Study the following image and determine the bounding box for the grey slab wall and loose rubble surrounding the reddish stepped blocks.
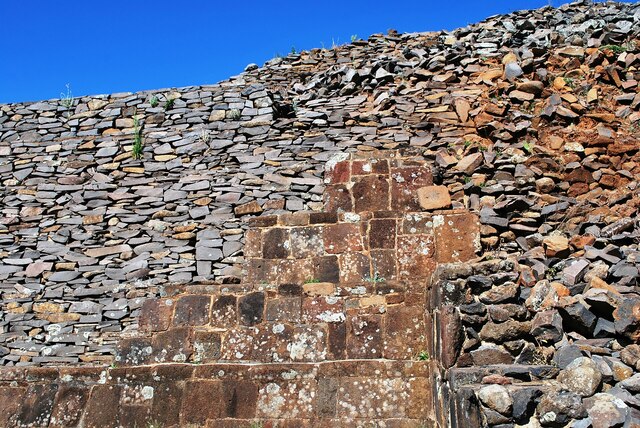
[0,3,640,426]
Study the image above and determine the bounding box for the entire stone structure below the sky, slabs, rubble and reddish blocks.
[0,2,640,427]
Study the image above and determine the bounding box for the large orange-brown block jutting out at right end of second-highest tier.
[433,213,480,263]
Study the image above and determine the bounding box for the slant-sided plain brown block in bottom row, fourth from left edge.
[83,385,121,428]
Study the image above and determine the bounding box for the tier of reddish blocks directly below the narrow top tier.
[245,210,480,284]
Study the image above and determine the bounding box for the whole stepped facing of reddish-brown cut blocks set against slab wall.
[3,152,479,427]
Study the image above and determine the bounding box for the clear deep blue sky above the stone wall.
[0,0,608,103]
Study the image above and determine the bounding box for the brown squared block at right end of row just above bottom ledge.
[383,306,427,360]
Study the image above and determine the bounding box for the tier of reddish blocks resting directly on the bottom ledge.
[116,281,430,365]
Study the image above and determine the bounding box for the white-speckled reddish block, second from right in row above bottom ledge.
[347,315,383,359]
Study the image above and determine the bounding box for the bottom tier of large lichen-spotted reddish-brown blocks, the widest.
[0,360,433,428]
